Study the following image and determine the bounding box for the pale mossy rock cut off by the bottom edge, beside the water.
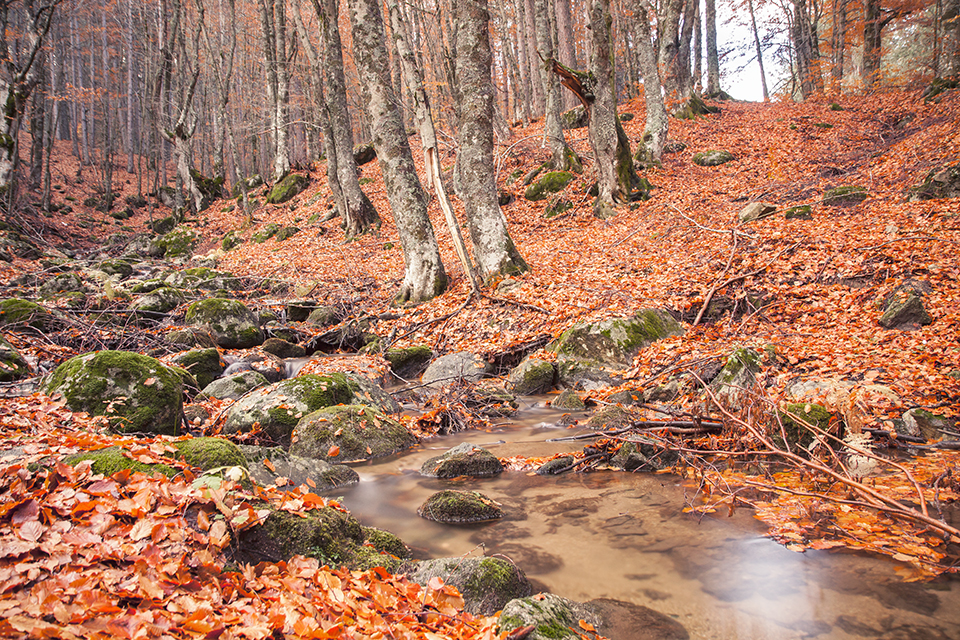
[500,593,601,640]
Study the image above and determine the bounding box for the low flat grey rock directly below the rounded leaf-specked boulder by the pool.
[240,445,360,491]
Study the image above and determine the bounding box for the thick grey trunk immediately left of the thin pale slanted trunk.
[350,0,447,304]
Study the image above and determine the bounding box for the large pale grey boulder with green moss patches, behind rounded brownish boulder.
[223,373,389,444]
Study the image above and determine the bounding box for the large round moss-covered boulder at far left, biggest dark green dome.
[43,351,183,434]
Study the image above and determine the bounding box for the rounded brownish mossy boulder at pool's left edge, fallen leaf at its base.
[290,404,417,462]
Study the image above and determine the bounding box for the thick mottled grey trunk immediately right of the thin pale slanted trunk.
[456,0,528,281]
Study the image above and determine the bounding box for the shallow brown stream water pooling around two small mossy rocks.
[342,409,960,640]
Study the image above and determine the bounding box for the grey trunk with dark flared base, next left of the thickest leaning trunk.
[313,0,378,238]
